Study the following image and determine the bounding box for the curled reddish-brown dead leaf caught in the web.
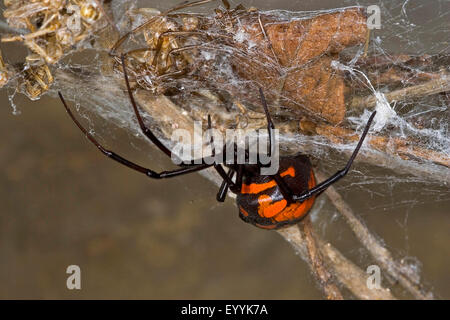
[233,8,367,123]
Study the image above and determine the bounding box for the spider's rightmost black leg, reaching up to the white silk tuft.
[293,111,377,202]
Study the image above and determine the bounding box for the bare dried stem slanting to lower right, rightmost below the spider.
[316,171,433,299]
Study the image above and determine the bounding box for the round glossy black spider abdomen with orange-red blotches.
[237,154,316,229]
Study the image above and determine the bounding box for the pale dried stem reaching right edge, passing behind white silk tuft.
[349,74,450,110]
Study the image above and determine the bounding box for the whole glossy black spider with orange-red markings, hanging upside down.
[58,56,376,229]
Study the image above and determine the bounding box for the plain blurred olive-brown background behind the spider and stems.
[0,0,450,299]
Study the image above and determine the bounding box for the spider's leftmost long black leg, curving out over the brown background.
[58,92,212,179]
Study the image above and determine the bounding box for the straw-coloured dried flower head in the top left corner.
[2,0,104,99]
